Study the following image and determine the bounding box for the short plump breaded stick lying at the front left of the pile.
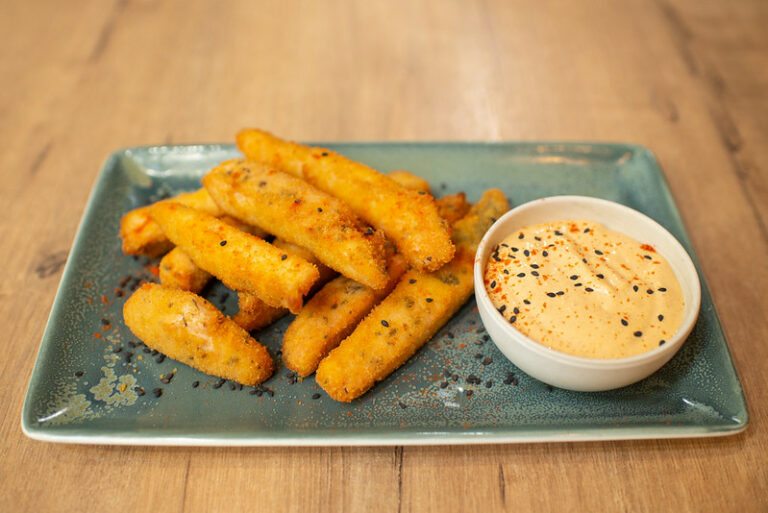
[123,283,274,386]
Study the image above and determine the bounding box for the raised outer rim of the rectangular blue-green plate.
[20,140,750,447]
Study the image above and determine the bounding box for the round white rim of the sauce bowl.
[474,195,701,370]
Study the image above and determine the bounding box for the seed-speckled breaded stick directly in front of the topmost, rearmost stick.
[203,159,387,289]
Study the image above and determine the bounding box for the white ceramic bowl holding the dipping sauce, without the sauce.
[474,196,701,392]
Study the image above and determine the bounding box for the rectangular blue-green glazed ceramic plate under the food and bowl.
[22,143,747,445]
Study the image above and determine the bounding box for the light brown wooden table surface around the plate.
[0,0,768,512]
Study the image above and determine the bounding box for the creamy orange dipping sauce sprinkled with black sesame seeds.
[484,220,685,358]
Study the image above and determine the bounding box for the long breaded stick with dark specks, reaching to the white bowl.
[315,191,509,402]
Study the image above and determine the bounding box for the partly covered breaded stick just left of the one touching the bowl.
[282,254,408,376]
